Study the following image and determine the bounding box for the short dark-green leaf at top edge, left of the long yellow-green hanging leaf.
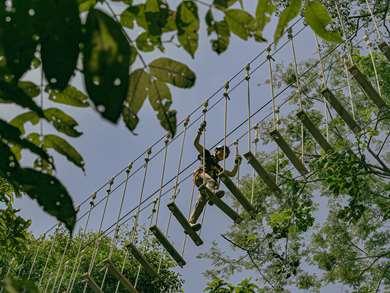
[145,0,170,36]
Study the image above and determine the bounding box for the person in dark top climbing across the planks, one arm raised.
[189,122,242,231]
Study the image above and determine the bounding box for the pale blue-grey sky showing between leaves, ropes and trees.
[1,4,354,293]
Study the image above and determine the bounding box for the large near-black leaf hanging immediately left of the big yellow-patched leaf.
[37,0,81,90]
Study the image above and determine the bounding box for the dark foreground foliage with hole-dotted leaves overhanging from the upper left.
[0,0,364,230]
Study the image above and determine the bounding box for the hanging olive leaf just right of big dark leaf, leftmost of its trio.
[123,69,150,131]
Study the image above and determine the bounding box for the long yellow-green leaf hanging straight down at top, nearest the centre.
[176,1,199,58]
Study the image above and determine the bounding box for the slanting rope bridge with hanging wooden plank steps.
[10,2,390,292]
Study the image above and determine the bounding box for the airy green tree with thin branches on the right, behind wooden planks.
[201,47,390,292]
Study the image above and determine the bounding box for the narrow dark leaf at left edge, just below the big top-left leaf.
[0,79,44,117]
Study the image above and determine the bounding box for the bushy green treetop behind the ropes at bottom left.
[0,227,182,292]
